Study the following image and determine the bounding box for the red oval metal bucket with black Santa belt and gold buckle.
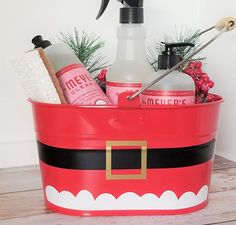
[32,92,222,215]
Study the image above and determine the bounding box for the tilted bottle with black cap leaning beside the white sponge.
[32,35,111,105]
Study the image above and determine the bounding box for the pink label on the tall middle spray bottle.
[106,81,142,105]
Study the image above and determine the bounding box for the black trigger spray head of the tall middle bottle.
[97,0,144,24]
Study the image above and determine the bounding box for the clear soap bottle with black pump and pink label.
[141,42,195,105]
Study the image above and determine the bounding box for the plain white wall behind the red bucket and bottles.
[0,0,236,168]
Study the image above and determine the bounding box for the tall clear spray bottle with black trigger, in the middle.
[97,0,154,104]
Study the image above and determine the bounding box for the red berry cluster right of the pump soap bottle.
[184,61,217,103]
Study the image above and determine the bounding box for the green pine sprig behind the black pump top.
[148,26,205,71]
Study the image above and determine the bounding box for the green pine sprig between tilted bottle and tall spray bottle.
[59,28,108,75]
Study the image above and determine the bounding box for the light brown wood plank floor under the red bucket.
[0,156,236,225]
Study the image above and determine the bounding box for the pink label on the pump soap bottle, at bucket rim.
[141,90,195,105]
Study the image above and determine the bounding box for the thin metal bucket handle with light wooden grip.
[127,17,236,100]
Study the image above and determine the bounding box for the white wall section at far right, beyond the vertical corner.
[200,0,236,161]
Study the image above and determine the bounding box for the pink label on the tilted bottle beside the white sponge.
[56,64,111,105]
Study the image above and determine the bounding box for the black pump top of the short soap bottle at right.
[158,42,195,70]
